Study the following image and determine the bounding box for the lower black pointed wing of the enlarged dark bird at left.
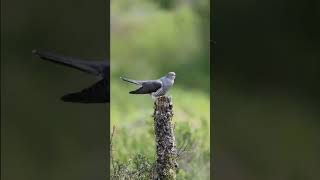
[61,79,110,103]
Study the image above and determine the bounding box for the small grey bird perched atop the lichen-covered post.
[120,72,176,98]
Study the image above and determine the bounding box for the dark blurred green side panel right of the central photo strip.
[211,0,320,180]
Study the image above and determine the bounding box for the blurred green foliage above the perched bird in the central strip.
[111,0,210,91]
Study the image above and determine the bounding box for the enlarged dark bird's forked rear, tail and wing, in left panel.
[32,49,110,104]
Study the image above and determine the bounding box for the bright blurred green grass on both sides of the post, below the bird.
[111,79,210,179]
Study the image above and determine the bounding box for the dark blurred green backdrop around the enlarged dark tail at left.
[1,0,109,180]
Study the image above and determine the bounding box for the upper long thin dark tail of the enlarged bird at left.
[32,50,109,76]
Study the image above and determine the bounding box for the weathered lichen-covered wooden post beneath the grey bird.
[153,96,177,180]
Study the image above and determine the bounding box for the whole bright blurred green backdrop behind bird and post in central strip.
[110,0,210,179]
